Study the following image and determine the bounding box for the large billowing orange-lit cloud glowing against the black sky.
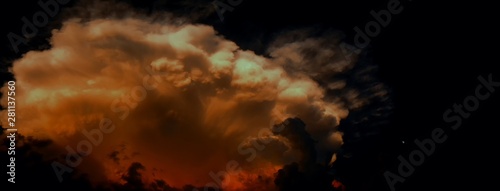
[2,1,388,190]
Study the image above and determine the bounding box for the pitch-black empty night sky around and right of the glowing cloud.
[0,0,500,191]
